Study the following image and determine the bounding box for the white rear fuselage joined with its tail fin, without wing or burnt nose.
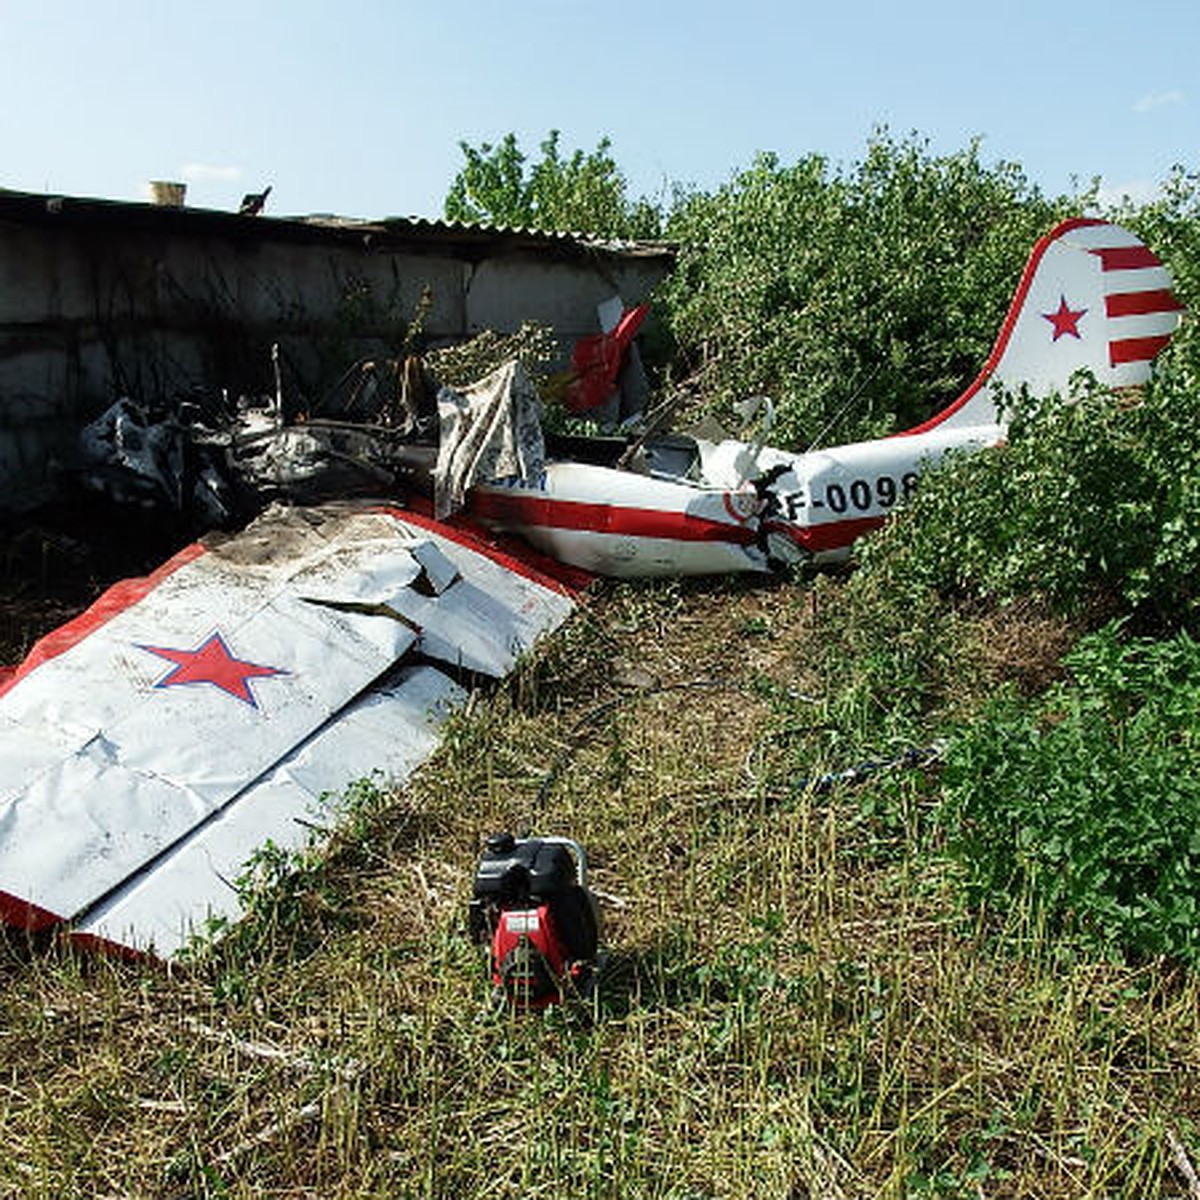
[468,220,1181,577]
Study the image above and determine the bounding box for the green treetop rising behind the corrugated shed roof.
[445,130,661,238]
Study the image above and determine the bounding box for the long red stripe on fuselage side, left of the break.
[470,492,755,546]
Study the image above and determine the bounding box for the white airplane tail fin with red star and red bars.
[906,217,1183,433]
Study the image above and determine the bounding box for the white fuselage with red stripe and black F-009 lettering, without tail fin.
[470,425,1003,578]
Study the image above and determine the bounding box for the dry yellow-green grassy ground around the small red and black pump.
[0,582,1200,1200]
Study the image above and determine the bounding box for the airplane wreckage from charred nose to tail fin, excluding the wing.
[72,218,1180,577]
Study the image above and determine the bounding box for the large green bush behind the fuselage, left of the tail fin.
[664,131,1085,448]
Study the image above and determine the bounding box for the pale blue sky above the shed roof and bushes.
[0,0,1200,217]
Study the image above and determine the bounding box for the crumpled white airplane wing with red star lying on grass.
[0,508,574,955]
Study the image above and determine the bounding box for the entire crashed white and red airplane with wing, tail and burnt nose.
[0,220,1180,956]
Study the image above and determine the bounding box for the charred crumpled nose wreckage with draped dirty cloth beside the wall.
[64,359,546,528]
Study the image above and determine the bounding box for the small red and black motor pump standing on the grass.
[469,833,600,1008]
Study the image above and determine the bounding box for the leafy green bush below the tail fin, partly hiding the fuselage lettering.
[862,309,1200,626]
